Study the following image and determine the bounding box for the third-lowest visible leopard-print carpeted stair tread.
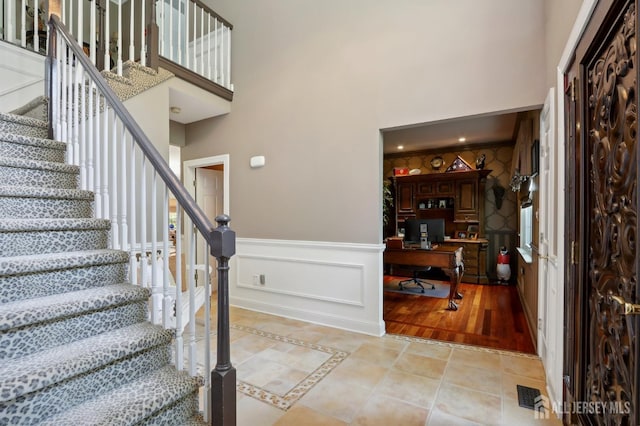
[0,284,150,332]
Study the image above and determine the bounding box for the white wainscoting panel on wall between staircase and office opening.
[229,238,384,335]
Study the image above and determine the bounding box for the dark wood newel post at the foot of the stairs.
[210,215,236,426]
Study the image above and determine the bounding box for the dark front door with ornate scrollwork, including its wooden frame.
[563,0,640,425]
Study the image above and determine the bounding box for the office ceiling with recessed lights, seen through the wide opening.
[383,112,518,154]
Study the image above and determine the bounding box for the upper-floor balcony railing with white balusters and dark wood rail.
[0,0,233,96]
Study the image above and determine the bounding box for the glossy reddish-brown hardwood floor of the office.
[383,275,535,354]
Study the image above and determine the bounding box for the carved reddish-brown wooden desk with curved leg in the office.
[383,246,464,311]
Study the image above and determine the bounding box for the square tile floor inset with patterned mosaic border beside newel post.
[230,324,349,411]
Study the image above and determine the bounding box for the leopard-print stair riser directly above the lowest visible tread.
[0,345,170,425]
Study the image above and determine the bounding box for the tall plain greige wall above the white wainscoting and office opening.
[183,0,556,243]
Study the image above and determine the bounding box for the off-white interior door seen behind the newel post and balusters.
[196,167,224,288]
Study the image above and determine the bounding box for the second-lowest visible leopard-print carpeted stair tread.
[0,322,173,402]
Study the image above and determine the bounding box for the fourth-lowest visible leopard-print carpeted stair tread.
[0,249,129,277]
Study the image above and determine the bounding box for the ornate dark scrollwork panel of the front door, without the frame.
[584,2,638,425]
